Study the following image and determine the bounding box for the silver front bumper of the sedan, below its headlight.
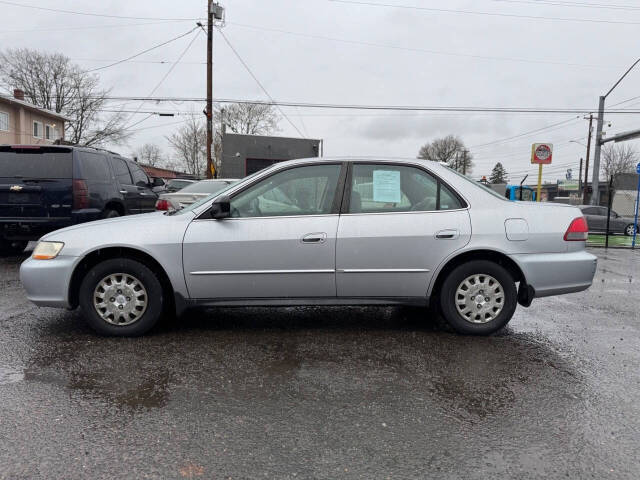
[20,255,78,308]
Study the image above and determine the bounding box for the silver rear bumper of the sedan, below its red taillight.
[511,250,598,298]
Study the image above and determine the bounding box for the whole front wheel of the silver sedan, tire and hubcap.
[80,258,164,336]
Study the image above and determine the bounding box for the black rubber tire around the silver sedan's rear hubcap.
[438,260,518,335]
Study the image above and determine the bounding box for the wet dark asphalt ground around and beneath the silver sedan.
[0,250,640,480]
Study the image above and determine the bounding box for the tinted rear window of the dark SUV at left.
[0,147,73,179]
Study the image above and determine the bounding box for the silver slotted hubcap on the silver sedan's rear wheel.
[455,273,504,323]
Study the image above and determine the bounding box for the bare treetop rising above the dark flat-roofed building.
[215,103,280,135]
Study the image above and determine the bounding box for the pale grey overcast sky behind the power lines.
[0,0,640,181]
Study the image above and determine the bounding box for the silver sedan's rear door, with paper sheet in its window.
[336,162,471,297]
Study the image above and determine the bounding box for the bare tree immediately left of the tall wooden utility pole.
[166,114,207,175]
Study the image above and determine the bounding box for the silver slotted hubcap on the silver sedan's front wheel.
[93,273,148,326]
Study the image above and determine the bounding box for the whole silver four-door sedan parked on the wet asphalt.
[20,158,596,336]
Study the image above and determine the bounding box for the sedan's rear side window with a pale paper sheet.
[349,164,461,213]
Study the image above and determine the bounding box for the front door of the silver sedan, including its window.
[183,162,346,299]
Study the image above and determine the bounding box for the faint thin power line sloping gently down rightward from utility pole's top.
[227,22,614,68]
